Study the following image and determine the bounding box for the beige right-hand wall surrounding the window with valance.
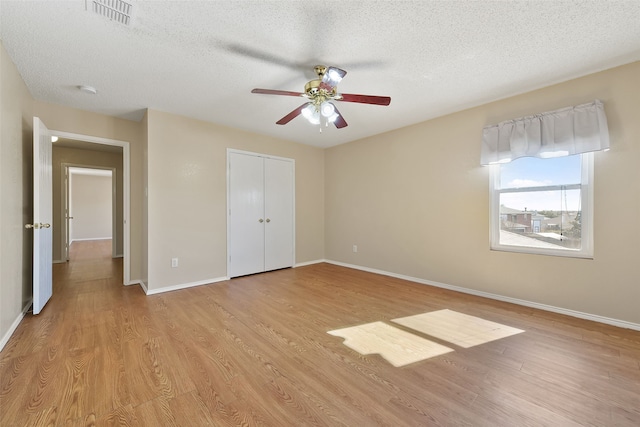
[325,62,640,324]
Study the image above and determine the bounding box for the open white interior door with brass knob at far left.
[27,117,53,314]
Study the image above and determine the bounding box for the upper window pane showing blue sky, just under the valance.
[500,155,582,188]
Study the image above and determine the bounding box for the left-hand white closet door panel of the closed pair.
[227,152,265,277]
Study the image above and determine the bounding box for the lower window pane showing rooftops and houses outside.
[500,190,582,250]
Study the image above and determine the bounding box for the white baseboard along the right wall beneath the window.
[325,260,640,331]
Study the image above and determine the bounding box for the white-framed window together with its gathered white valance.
[480,99,610,258]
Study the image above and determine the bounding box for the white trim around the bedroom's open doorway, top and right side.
[49,129,133,286]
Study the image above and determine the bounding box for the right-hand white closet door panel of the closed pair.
[264,158,294,271]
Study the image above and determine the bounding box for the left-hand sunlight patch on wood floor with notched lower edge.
[327,322,453,367]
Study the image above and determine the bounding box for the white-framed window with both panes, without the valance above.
[490,153,593,258]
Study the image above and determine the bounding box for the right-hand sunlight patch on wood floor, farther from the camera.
[391,310,524,348]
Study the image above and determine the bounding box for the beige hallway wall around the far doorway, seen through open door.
[52,144,124,260]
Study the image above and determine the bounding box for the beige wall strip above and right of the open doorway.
[34,101,144,281]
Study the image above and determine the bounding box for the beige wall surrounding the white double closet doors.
[147,110,324,291]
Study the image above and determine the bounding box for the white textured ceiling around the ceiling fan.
[0,0,640,147]
